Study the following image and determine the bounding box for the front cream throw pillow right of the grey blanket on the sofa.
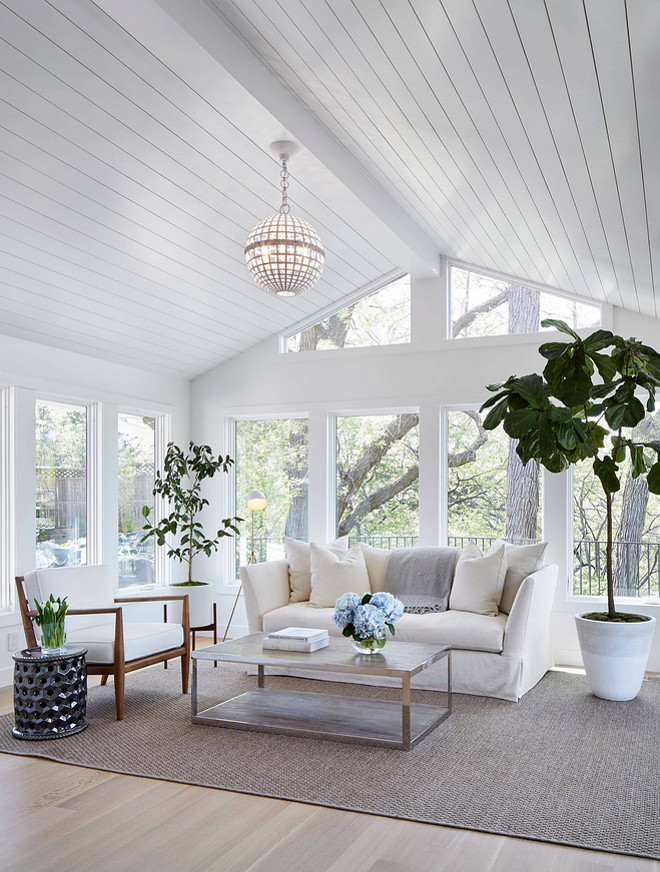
[449,542,506,615]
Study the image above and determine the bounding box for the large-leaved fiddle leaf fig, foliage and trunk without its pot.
[481,319,660,621]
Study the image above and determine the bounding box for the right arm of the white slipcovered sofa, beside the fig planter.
[502,564,558,657]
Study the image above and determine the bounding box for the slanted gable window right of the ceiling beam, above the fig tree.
[449,266,600,339]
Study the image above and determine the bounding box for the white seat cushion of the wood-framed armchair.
[66,623,183,663]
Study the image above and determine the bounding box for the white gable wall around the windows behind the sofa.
[192,279,660,671]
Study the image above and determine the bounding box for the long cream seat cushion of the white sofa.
[263,603,507,654]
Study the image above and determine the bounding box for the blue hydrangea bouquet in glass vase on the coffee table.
[332,591,403,654]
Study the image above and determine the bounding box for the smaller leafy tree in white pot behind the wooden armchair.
[140,442,242,627]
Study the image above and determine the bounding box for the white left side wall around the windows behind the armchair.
[0,336,190,685]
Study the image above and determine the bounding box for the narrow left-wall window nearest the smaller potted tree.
[118,413,156,588]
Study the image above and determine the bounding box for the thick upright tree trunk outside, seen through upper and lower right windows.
[504,285,541,539]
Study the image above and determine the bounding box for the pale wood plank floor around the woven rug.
[0,676,660,872]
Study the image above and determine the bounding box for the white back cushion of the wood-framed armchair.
[25,565,117,633]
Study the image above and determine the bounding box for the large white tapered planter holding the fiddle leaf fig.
[575,614,655,701]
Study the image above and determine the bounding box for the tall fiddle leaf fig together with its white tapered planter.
[482,319,660,700]
